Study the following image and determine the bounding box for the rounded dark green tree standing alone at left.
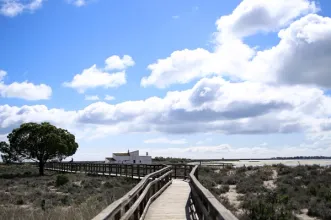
[0,122,78,175]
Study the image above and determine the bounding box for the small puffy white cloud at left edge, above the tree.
[0,70,52,100]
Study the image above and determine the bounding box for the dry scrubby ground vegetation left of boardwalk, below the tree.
[0,164,136,220]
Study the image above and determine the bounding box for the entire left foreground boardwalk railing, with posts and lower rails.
[93,166,173,220]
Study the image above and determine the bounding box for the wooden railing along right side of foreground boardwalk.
[190,166,238,220]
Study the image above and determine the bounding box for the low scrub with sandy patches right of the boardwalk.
[199,164,331,220]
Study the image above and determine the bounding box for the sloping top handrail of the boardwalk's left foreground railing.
[92,166,171,220]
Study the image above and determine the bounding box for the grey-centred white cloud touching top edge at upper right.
[216,0,318,37]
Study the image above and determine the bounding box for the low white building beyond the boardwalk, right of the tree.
[105,150,152,164]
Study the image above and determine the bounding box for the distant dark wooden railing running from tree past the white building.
[45,162,165,179]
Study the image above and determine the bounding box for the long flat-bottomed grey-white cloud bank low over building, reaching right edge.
[78,78,331,134]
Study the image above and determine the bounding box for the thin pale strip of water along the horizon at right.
[193,160,331,167]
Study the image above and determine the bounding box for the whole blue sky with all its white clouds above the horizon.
[0,0,331,160]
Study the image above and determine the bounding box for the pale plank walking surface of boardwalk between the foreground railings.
[145,179,191,220]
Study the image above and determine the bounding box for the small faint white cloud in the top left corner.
[0,0,44,17]
